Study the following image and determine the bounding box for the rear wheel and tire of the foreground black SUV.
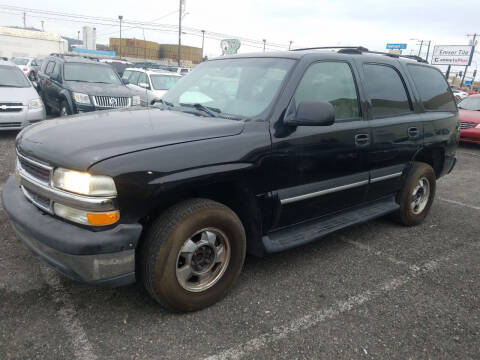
[395,162,436,226]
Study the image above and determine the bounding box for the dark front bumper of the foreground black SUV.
[2,175,142,286]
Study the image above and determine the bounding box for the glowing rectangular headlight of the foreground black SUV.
[52,168,117,196]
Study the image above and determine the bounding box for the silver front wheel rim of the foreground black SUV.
[176,228,231,292]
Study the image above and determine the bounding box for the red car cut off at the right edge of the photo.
[458,94,480,144]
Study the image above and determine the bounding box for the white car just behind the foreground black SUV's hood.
[122,68,181,106]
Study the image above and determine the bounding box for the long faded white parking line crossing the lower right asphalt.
[204,243,478,360]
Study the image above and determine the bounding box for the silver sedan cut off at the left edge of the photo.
[0,60,45,130]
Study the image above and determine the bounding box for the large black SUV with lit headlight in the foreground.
[2,48,459,311]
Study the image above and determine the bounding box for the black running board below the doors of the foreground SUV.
[262,196,400,253]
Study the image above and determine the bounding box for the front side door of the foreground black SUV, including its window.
[273,61,370,227]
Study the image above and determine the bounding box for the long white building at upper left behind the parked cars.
[0,27,68,58]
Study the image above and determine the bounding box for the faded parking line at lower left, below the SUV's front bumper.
[41,265,97,360]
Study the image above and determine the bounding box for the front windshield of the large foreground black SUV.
[164,58,295,117]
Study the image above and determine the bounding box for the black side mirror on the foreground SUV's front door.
[285,101,335,126]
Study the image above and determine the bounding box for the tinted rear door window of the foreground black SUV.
[364,64,412,118]
